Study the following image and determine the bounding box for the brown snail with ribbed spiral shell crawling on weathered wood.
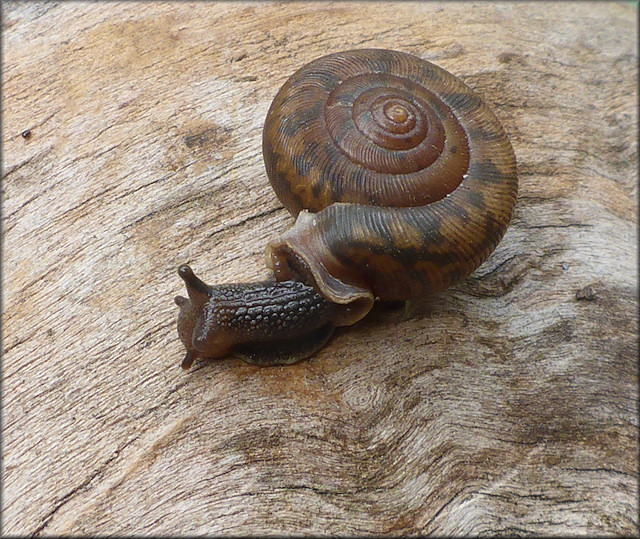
[175,49,518,368]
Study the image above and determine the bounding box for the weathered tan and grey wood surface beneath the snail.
[2,2,638,535]
